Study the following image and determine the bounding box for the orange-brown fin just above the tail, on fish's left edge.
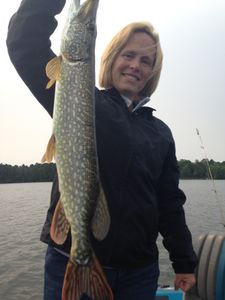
[50,199,70,245]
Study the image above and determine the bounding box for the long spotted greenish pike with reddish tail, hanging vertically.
[43,0,113,300]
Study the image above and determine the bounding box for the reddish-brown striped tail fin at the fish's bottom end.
[62,256,113,300]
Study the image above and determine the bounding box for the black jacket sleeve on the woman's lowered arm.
[158,141,197,273]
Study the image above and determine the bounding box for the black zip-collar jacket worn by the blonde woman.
[7,0,196,273]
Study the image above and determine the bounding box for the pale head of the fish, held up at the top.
[60,0,99,62]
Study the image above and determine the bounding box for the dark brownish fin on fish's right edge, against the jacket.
[91,184,111,241]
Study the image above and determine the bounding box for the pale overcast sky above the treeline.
[0,0,225,165]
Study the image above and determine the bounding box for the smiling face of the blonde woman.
[112,32,156,100]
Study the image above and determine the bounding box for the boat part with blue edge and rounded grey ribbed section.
[156,234,225,300]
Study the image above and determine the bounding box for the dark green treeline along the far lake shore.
[0,159,225,183]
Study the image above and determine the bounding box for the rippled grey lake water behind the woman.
[0,180,225,300]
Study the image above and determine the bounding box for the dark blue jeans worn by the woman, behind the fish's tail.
[44,246,159,300]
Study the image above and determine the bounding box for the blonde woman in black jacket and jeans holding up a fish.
[7,0,197,300]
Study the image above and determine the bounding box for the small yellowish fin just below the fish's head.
[45,55,62,89]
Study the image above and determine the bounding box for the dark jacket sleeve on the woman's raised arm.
[6,0,65,116]
